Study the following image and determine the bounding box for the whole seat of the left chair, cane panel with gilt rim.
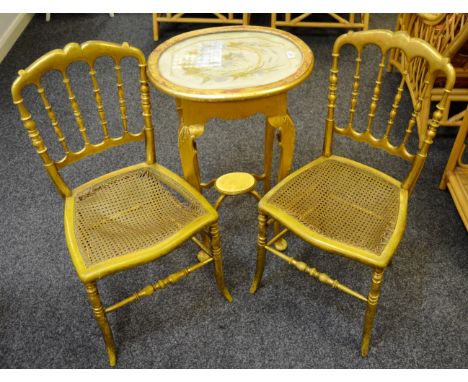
[65,165,216,279]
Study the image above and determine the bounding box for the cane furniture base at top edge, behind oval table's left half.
[152,13,251,41]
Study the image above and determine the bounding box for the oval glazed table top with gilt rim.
[148,26,314,101]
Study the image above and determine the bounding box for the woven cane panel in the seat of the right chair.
[269,159,400,255]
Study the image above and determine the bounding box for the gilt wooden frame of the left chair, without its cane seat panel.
[11,41,232,366]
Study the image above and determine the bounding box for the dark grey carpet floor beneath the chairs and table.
[0,14,468,368]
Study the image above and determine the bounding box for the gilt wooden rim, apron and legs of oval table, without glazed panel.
[148,26,314,212]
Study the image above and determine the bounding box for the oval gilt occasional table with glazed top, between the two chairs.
[148,26,314,197]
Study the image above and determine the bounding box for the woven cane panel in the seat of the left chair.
[74,168,206,267]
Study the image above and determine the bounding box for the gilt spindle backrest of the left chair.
[11,41,155,196]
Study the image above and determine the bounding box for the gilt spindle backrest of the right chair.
[323,30,455,192]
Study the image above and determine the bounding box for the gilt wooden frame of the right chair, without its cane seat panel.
[250,30,455,357]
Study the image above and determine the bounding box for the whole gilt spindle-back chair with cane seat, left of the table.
[12,41,232,366]
